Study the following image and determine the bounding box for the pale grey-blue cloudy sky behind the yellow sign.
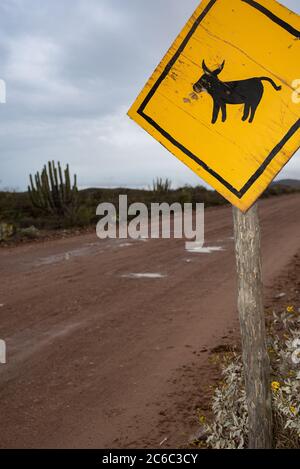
[0,0,300,190]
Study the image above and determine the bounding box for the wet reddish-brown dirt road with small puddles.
[0,195,300,448]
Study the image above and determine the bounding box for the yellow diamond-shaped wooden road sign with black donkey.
[128,0,300,211]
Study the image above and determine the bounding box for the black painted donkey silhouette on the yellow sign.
[193,60,281,124]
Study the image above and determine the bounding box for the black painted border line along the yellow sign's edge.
[137,0,300,199]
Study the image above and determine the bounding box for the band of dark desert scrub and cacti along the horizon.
[0,161,299,241]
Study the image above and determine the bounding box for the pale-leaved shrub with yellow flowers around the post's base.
[201,307,300,449]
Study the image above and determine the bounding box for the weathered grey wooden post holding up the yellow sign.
[233,204,272,449]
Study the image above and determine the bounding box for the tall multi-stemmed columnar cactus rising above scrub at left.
[28,161,78,217]
